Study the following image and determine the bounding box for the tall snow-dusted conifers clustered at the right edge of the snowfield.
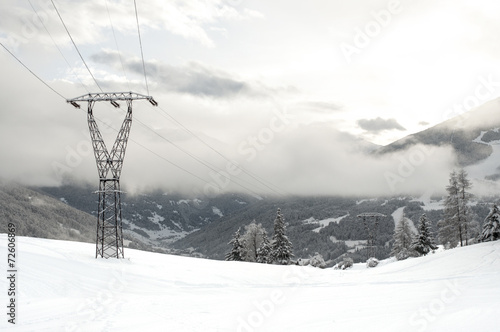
[391,169,500,260]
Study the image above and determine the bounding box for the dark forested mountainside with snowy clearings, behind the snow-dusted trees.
[171,197,489,265]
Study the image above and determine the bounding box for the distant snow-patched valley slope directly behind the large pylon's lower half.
[34,184,259,248]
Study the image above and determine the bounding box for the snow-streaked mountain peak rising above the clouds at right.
[375,98,500,170]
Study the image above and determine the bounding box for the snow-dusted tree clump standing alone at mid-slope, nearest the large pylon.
[225,209,293,265]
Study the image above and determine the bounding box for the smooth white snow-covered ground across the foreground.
[0,234,500,332]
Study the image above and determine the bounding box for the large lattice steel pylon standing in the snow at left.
[67,92,158,258]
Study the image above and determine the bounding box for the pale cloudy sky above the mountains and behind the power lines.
[0,0,500,195]
